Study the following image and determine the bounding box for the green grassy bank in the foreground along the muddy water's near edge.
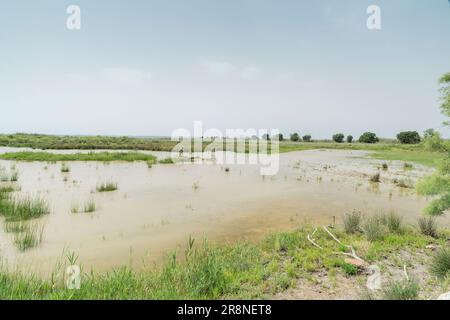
[0,218,449,299]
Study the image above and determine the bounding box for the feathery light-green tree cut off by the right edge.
[416,72,450,215]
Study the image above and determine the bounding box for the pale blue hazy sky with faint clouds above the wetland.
[0,0,450,138]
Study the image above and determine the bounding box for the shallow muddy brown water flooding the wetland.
[0,149,449,273]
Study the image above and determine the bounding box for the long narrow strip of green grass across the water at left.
[0,151,156,164]
